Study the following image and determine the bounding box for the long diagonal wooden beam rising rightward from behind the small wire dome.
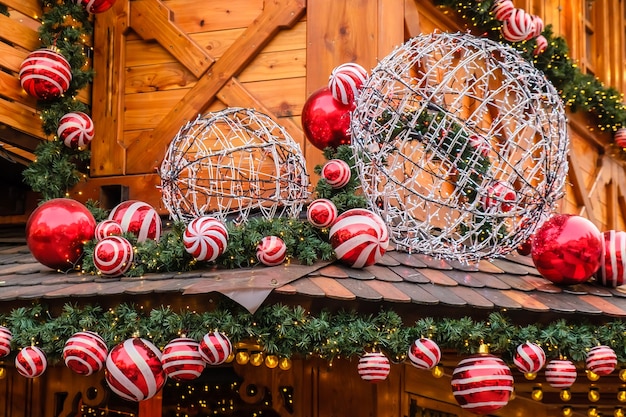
[127,0,305,174]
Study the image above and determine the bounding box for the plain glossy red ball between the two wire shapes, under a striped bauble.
[301,87,351,150]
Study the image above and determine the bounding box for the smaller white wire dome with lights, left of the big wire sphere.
[159,108,310,224]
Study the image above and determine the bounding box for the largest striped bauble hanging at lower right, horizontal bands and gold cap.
[452,354,513,414]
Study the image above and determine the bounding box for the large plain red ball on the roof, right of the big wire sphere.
[531,214,602,285]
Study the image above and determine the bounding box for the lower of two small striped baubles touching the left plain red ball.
[93,236,134,277]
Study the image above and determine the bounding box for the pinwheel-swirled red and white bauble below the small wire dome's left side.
[183,216,228,262]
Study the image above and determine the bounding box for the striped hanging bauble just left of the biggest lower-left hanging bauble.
[63,331,109,375]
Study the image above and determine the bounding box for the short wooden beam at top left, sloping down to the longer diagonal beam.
[130,0,215,77]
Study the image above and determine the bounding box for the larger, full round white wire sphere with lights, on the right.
[351,33,568,262]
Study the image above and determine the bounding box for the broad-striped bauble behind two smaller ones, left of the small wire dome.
[109,200,162,242]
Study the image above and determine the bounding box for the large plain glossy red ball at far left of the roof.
[26,198,96,271]
